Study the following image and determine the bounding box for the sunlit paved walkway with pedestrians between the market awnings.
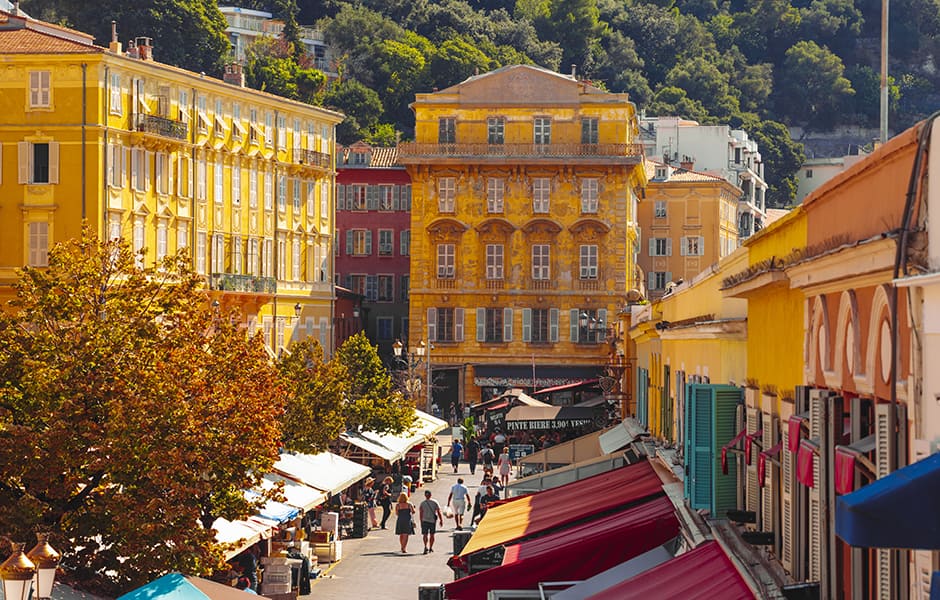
[304,436,482,600]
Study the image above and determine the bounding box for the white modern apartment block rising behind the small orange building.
[640,117,767,242]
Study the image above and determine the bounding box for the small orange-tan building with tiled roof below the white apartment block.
[638,160,741,299]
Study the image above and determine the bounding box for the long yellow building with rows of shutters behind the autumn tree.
[0,13,342,351]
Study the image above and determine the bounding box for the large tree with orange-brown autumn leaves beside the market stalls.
[0,228,284,595]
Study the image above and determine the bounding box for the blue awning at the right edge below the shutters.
[836,454,940,550]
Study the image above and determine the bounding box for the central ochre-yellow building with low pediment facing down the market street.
[399,66,646,408]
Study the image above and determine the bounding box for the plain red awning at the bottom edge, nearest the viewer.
[585,542,754,600]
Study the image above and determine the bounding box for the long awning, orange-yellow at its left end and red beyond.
[460,461,665,556]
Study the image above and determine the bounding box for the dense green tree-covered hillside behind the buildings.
[22,0,940,206]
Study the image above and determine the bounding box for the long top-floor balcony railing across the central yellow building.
[398,142,643,162]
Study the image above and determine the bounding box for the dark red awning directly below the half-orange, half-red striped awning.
[444,497,679,600]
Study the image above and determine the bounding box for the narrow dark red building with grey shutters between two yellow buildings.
[336,143,411,363]
